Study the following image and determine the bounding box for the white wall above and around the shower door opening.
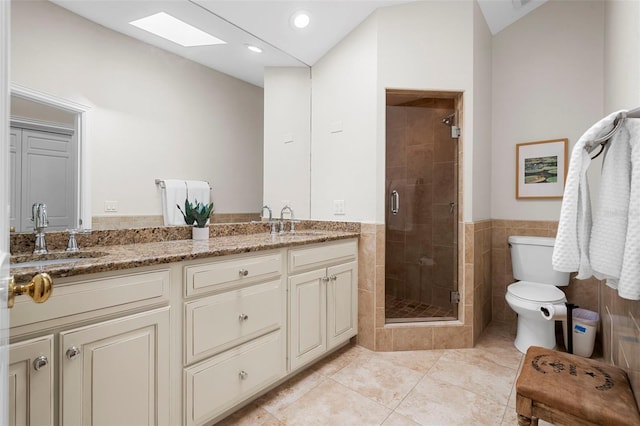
[376,1,474,223]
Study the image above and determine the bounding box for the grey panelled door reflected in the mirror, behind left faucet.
[10,122,78,232]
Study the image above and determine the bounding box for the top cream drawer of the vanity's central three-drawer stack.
[185,252,282,296]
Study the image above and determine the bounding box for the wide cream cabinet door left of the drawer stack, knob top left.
[60,307,170,426]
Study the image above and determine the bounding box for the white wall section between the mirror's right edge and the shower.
[311,16,384,223]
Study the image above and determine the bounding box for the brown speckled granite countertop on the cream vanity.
[10,230,359,283]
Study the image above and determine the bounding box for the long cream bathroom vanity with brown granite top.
[10,231,358,425]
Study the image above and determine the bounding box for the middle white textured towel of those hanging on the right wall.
[589,120,631,286]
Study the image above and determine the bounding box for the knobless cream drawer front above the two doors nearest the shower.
[289,240,358,272]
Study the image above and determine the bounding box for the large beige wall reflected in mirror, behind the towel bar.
[11,1,263,215]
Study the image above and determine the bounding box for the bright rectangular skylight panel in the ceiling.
[129,12,226,47]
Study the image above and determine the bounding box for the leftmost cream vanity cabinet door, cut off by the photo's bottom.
[9,335,53,426]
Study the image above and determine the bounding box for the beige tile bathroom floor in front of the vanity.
[219,323,549,426]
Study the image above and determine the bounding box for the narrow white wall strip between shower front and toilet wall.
[472,2,493,221]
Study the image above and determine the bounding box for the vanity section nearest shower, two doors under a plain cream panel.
[288,240,358,371]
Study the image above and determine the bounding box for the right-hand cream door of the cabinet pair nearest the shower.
[327,262,358,349]
